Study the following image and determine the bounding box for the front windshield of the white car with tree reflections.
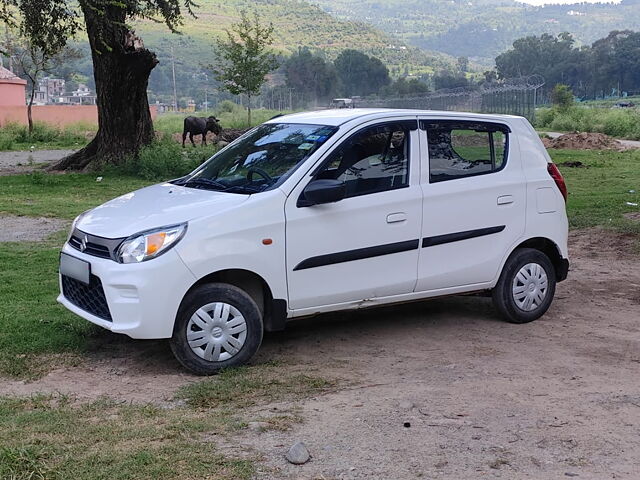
[174,123,337,194]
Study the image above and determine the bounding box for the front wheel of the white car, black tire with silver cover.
[170,283,264,375]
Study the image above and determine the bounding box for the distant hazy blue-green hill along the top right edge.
[316,0,640,63]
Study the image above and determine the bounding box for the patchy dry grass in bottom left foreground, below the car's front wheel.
[0,364,334,480]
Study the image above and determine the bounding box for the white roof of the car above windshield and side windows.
[267,108,520,127]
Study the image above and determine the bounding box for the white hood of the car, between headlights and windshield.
[76,183,249,238]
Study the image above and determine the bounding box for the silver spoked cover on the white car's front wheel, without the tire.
[187,302,247,362]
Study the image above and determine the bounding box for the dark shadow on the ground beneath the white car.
[81,296,500,375]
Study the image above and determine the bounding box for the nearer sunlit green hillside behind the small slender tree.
[127,0,451,96]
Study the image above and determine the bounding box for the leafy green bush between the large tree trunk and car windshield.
[117,138,218,180]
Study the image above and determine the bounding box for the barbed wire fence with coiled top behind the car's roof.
[357,75,545,121]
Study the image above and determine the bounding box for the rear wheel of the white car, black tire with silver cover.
[492,248,556,323]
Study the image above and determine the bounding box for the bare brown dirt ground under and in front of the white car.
[0,230,640,480]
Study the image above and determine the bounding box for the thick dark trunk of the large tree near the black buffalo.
[51,0,158,170]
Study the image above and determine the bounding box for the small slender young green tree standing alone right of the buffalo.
[210,12,278,125]
